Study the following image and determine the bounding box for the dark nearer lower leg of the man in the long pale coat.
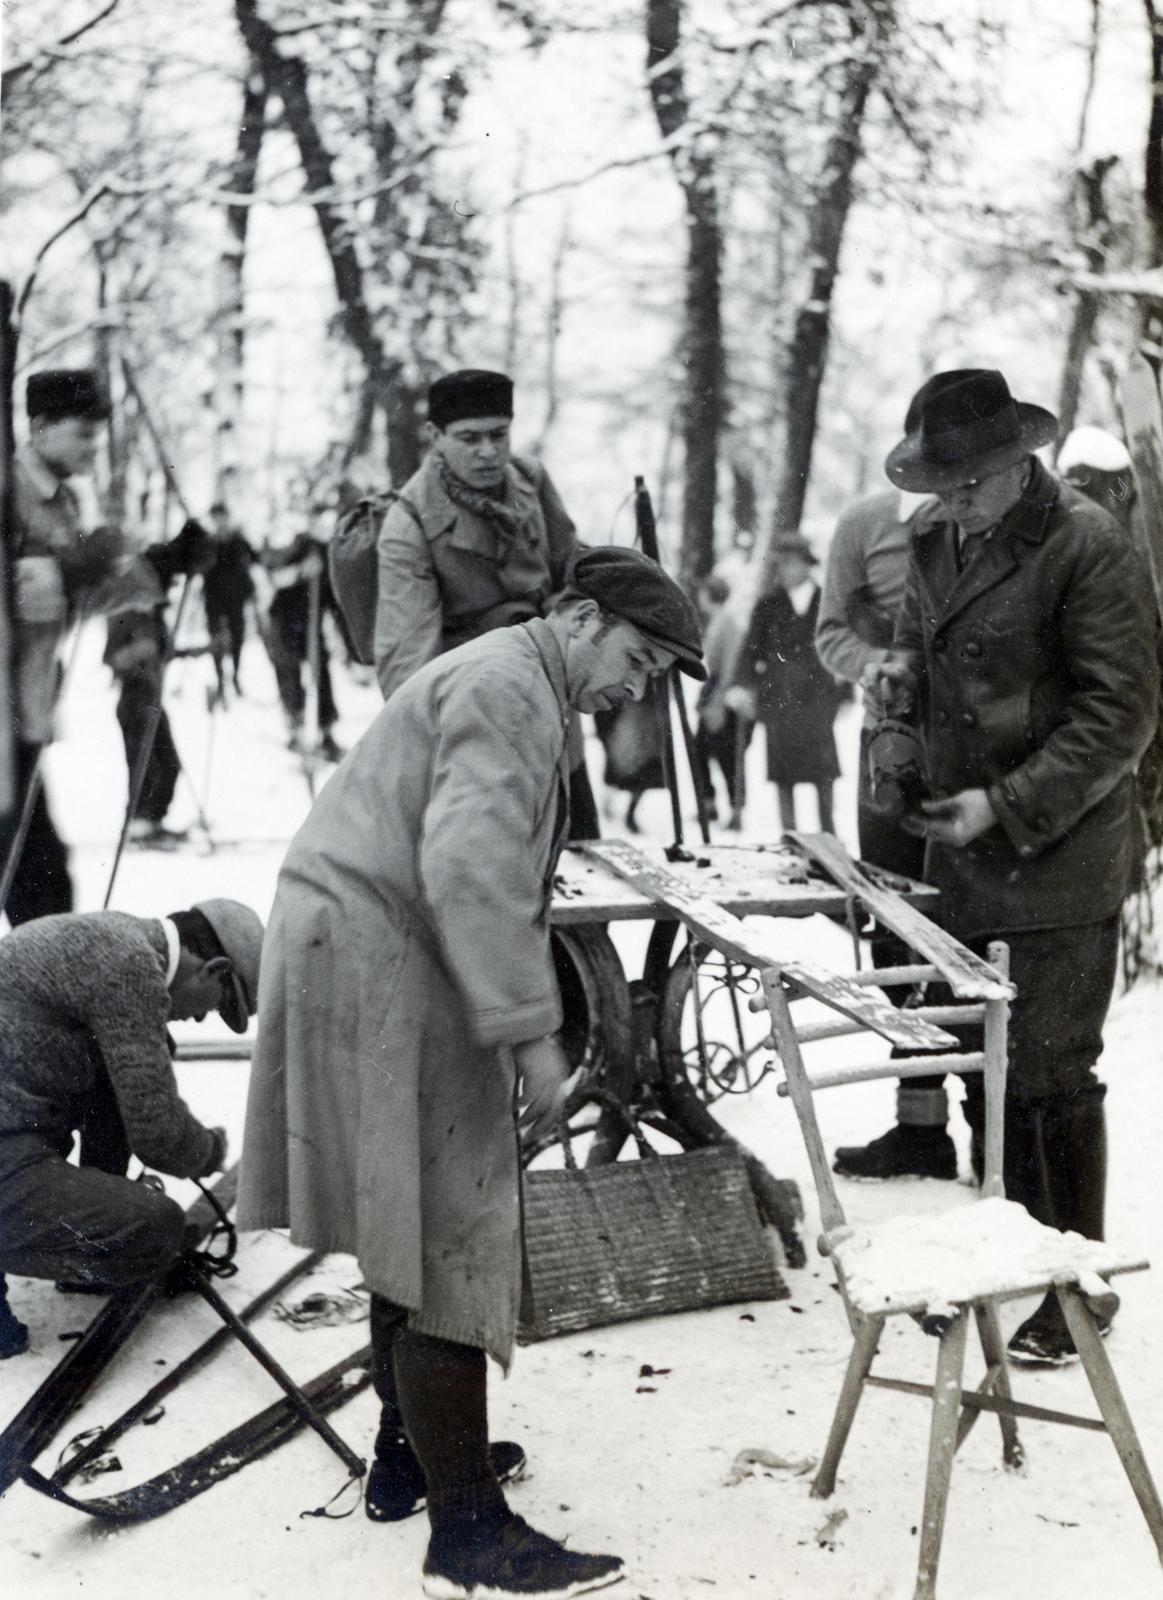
[392,1326,507,1530]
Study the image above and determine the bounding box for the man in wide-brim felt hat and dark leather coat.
[867,368,1158,1362]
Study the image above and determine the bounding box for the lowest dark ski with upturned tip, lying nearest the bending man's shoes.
[22,1344,371,1523]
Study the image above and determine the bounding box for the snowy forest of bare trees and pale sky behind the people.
[2,0,1163,595]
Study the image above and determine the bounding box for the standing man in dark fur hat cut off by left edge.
[0,368,122,925]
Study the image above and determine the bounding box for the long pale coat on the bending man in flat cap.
[238,619,570,1363]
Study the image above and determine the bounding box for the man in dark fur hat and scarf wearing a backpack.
[374,368,598,838]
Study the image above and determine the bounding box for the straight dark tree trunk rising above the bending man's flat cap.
[646,0,726,589]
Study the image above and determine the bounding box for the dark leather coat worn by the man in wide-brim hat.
[894,461,1158,939]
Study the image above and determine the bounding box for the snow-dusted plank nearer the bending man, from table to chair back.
[582,838,957,1050]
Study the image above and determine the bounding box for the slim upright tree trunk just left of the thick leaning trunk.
[214,56,269,499]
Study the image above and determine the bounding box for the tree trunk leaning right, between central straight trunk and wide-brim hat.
[765,40,877,581]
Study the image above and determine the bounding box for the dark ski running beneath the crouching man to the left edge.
[0,1166,238,1494]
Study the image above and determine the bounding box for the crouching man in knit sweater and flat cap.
[0,899,262,1355]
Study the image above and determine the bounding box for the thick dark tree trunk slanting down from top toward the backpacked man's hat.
[234,0,397,444]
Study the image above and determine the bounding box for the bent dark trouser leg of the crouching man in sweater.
[0,1134,186,1288]
